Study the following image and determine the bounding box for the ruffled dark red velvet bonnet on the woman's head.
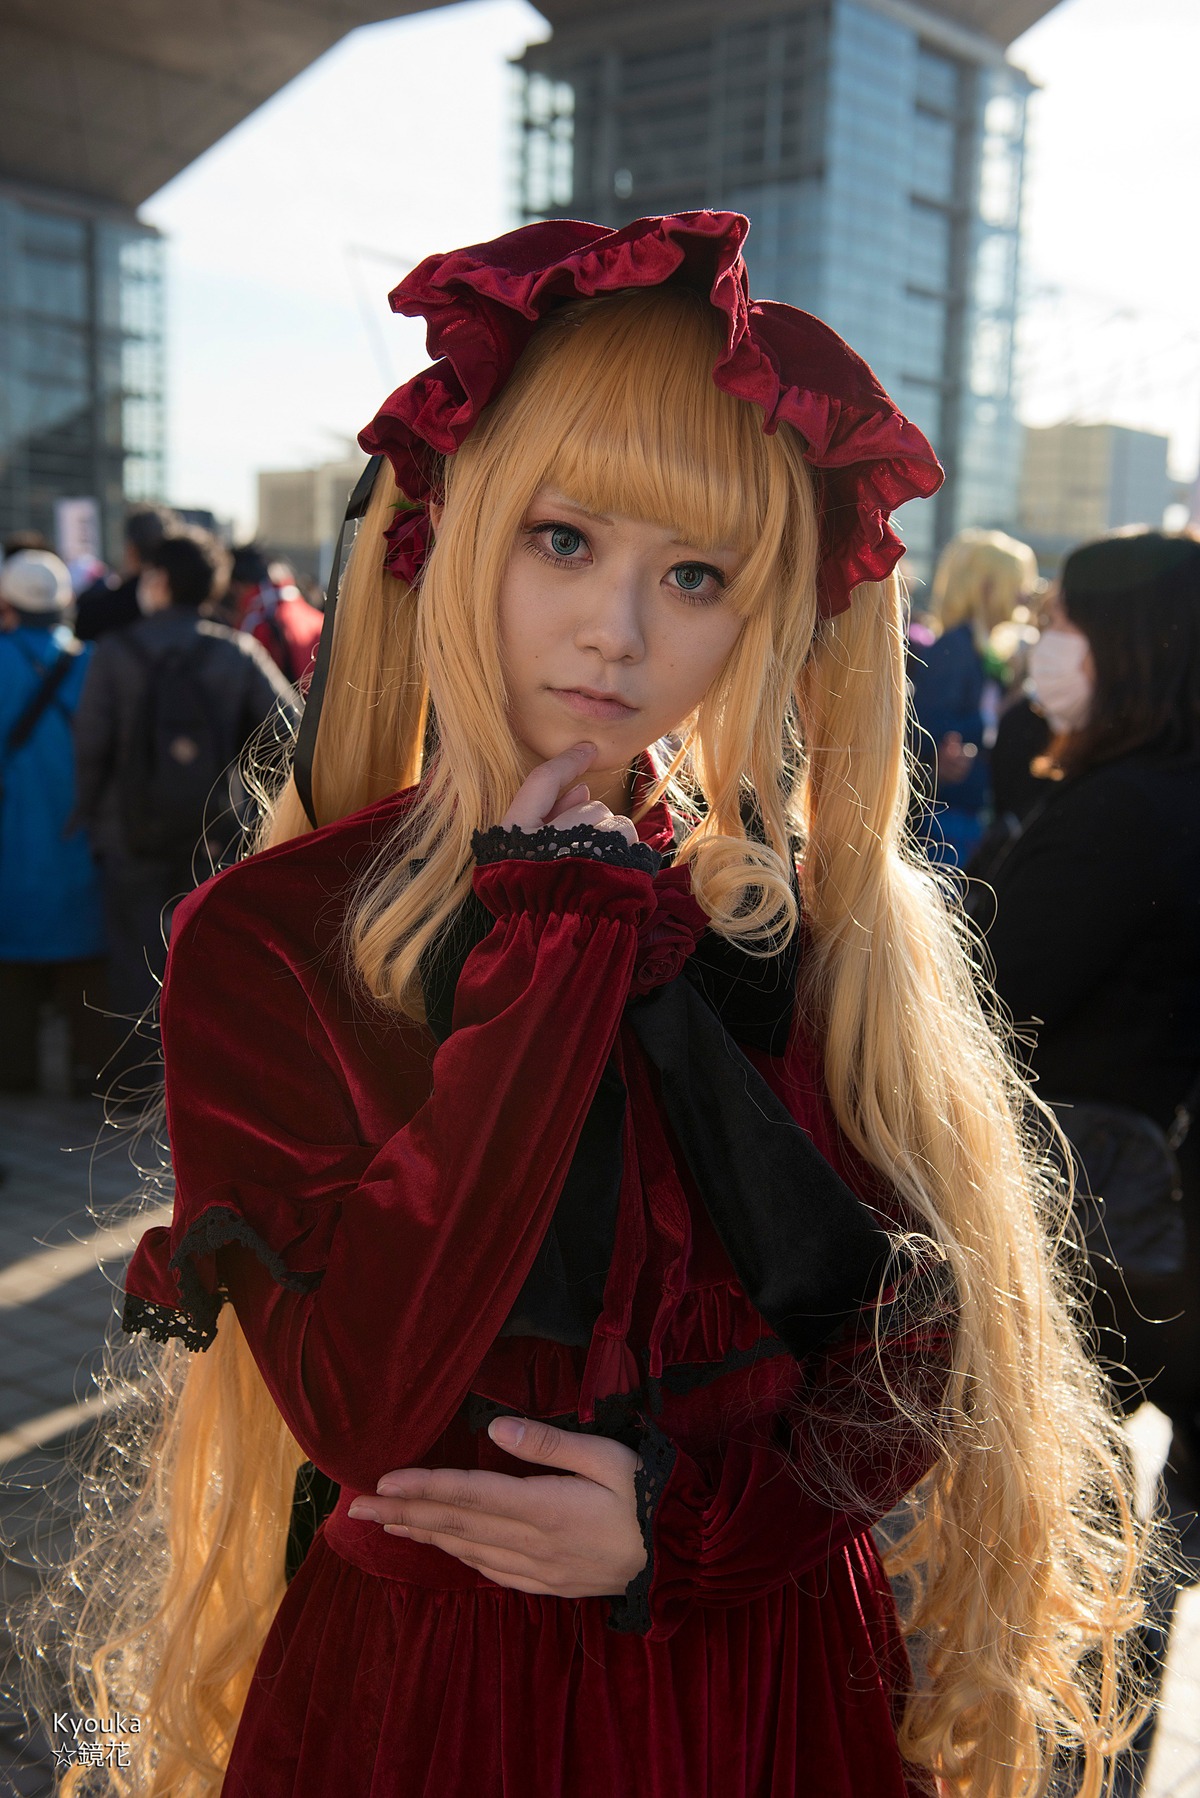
[358,212,943,617]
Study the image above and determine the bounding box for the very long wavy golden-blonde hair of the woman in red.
[18,289,1139,1798]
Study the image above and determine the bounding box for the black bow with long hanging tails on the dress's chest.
[421,848,891,1357]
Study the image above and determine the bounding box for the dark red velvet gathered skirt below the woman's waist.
[221,1516,928,1798]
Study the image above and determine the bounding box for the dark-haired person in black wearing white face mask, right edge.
[968,530,1200,1459]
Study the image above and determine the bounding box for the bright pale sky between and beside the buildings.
[142,0,1200,532]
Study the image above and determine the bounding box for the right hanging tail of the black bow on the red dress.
[628,975,891,1359]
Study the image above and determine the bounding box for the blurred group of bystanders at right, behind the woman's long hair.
[909,530,1200,1794]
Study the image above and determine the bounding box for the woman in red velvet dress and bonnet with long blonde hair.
[30,212,1137,1798]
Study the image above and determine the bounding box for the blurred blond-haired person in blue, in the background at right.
[909,530,1038,868]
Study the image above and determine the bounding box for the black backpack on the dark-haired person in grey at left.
[119,636,236,859]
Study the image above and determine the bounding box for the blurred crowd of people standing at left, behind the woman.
[0,507,322,1104]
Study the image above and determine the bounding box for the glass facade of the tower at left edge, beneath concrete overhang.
[0,185,164,561]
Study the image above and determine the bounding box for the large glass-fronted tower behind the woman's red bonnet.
[518,0,1031,579]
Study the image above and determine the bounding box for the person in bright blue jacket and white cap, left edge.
[0,550,106,1093]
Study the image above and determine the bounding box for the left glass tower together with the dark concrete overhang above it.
[0,0,444,559]
